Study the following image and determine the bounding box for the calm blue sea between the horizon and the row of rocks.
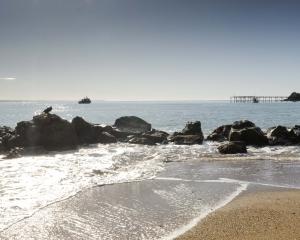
[0,101,300,133]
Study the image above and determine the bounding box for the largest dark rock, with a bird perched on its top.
[13,113,78,150]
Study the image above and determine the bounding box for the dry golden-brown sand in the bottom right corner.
[177,190,300,240]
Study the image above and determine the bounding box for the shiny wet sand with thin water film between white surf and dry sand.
[0,158,300,240]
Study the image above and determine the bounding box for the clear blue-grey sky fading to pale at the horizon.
[0,0,300,100]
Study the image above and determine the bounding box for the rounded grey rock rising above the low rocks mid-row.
[114,116,151,133]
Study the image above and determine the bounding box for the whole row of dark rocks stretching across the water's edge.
[0,112,300,158]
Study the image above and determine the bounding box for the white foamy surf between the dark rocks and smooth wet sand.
[0,142,300,230]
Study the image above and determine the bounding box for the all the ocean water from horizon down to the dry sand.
[0,101,300,239]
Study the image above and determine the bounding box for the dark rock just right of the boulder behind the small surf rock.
[267,126,293,145]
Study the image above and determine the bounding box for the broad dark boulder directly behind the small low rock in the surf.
[229,127,268,146]
